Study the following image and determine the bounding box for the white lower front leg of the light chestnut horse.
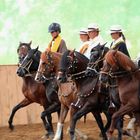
[53,123,64,140]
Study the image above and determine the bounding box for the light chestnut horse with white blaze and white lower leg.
[35,50,87,140]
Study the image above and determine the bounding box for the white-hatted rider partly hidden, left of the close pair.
[79,28,89,54]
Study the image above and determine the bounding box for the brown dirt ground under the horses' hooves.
[0,120,133,140]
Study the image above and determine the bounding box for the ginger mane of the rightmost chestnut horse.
[105,50,136,71]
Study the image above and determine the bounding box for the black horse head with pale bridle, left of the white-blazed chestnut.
[17,47,41,77]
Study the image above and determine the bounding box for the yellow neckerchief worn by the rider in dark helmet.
[48,35,62,52]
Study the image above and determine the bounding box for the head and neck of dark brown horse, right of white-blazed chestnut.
[57,50,89,82]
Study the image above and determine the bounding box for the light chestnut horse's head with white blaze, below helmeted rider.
[35,50,62,83]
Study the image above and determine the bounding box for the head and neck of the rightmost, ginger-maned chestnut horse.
[100,50,137,83]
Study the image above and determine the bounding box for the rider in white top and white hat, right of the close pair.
[80,23,104,58]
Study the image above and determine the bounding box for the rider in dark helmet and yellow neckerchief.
[47,23,67,53]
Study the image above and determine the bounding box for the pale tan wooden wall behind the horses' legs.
[0,65,98,126]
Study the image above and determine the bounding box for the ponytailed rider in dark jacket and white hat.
[110,25,130,57]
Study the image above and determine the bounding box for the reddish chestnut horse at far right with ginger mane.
[100,50,140,139]
